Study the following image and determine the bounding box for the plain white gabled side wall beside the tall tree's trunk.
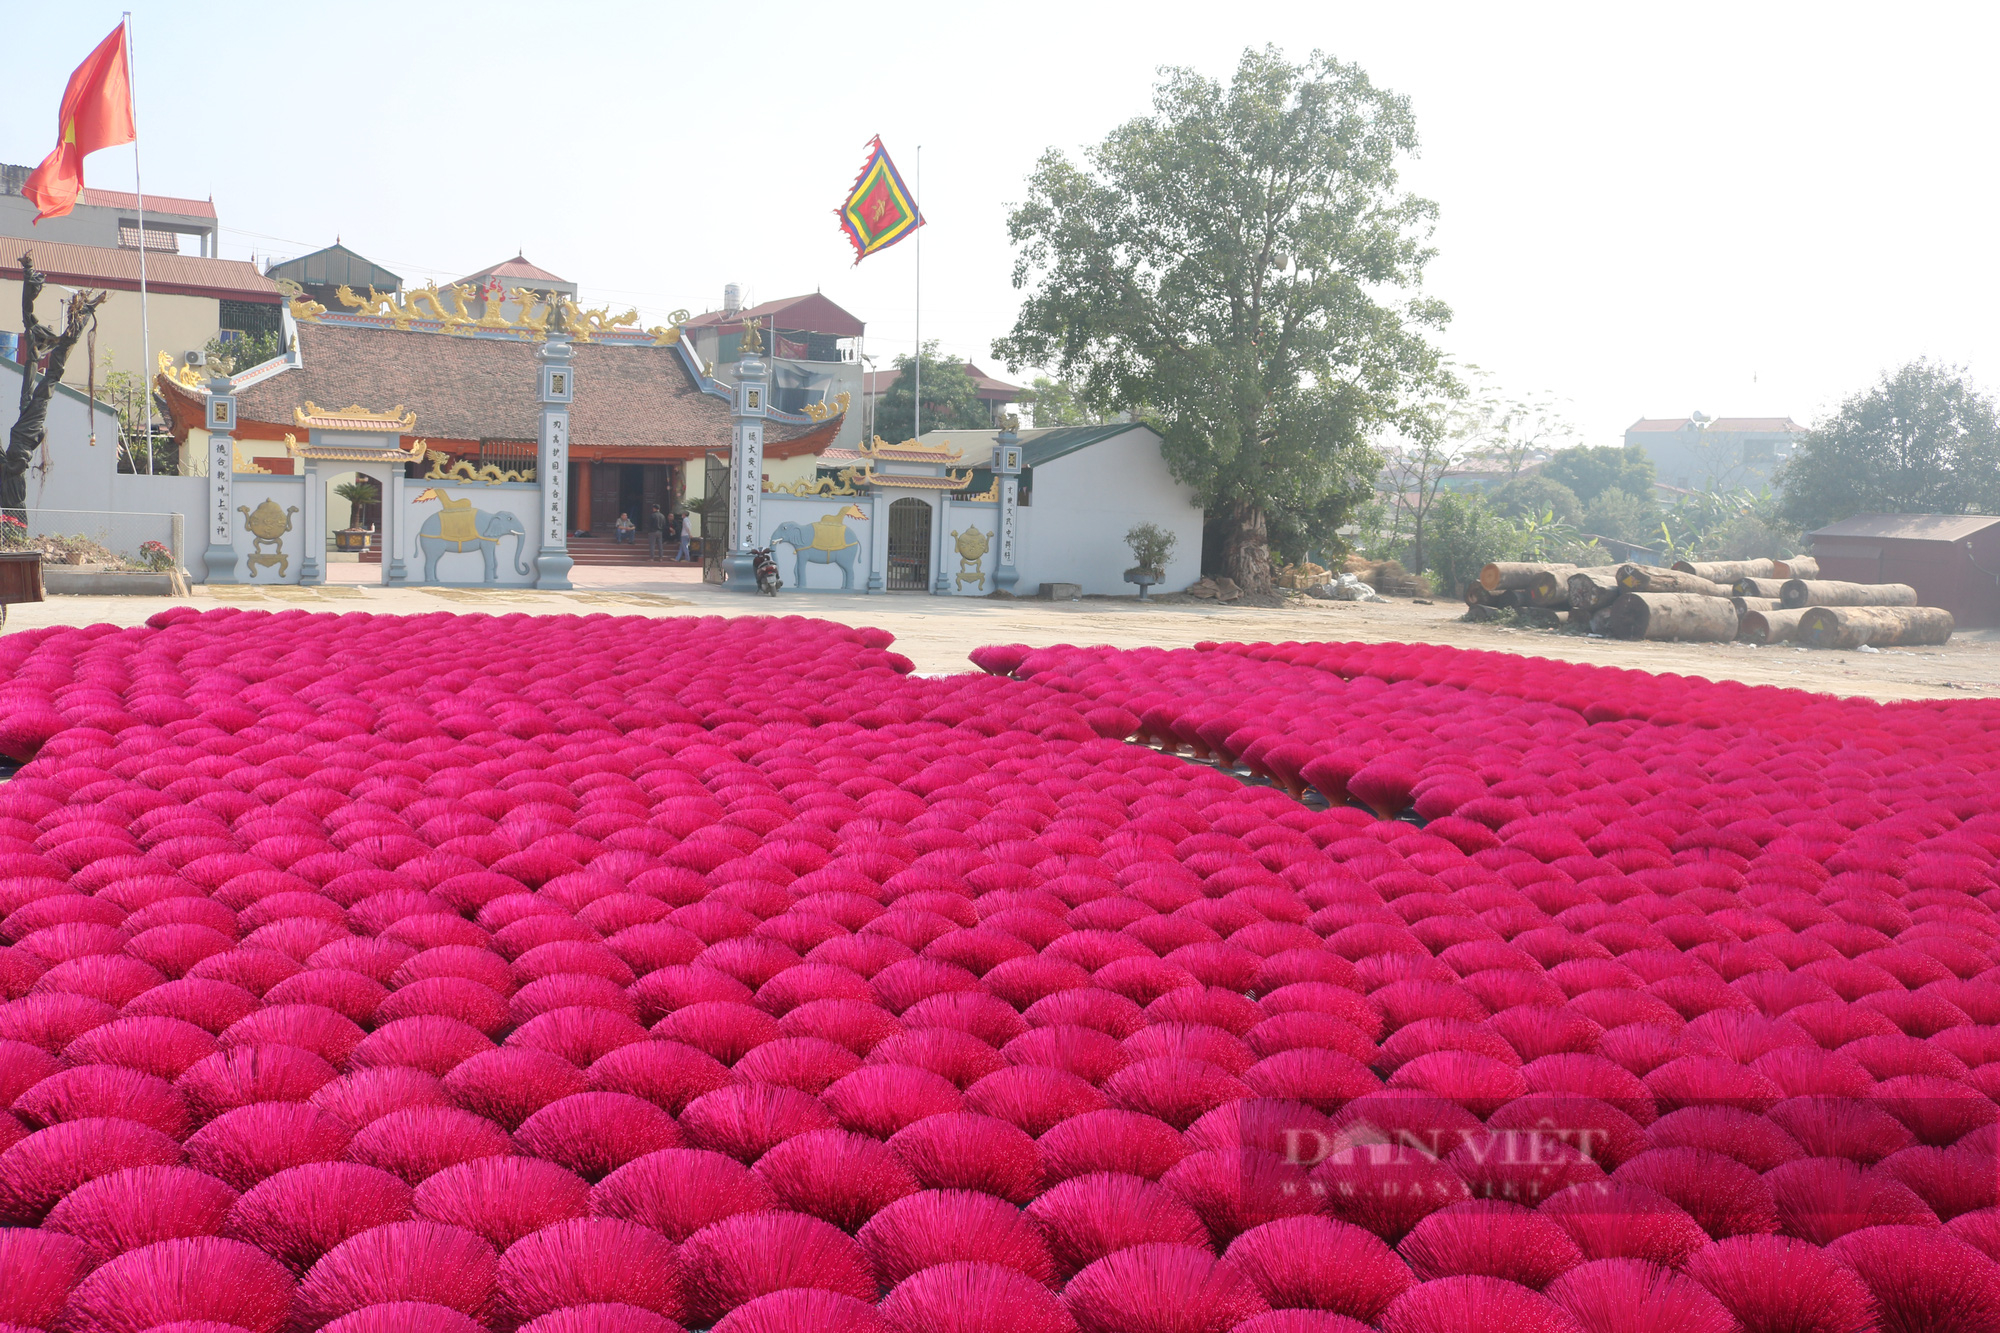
[1016,426,1202,596]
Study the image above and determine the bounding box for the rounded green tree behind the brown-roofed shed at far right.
[1774,360,2000,530]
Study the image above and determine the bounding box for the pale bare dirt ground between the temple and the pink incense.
[4,566,2000,699]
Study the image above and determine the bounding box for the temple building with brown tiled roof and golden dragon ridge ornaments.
[158,284,844,558]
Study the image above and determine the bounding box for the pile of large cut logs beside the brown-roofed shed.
[1464,556,1954,648]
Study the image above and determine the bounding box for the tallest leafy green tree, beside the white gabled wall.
[994,48,1450,588]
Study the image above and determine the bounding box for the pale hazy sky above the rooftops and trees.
[0,0,2000,444]
